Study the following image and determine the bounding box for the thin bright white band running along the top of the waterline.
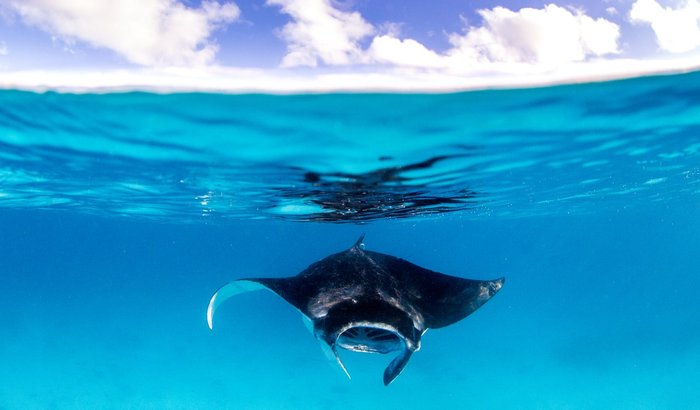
[0,57,700,94]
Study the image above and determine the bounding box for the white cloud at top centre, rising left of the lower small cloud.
[267,0,374,67]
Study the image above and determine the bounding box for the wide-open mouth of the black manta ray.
[336,323,405,353]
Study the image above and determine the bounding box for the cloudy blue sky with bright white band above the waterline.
[0,0,700,92]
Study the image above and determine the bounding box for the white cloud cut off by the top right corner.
[630,0,700,53]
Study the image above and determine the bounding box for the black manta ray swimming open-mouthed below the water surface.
[207,234,505,385]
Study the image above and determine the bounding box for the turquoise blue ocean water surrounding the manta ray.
[0,73,700,409]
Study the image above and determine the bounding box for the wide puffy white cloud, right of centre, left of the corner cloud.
[450,4,620,64]
